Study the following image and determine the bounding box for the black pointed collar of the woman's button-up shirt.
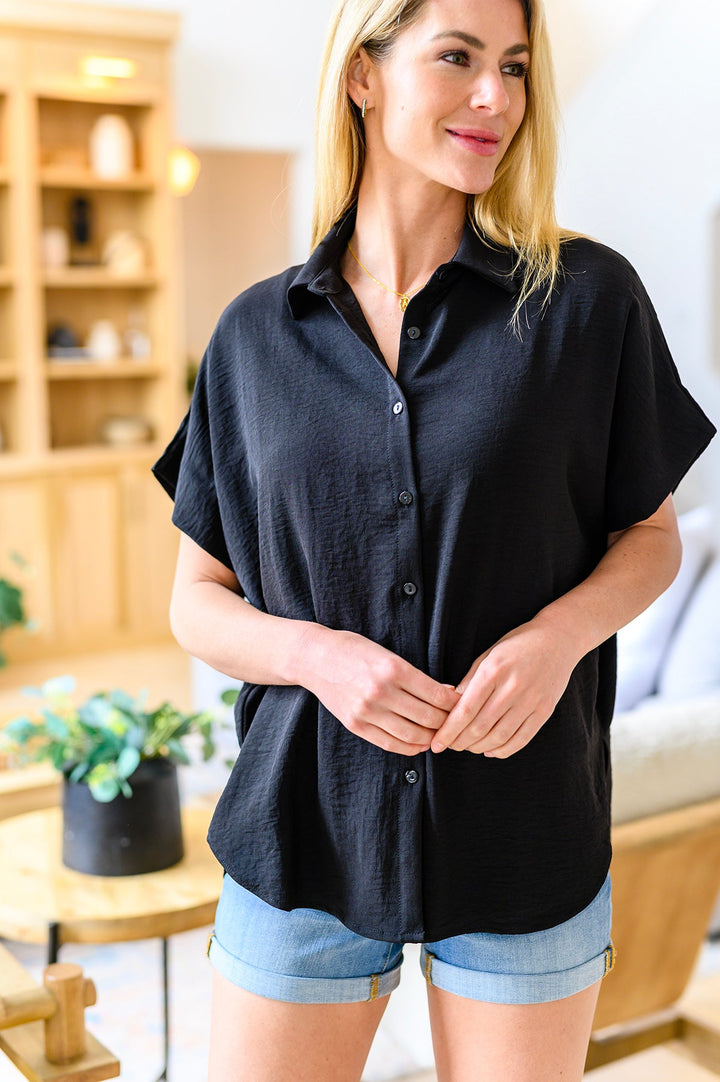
[287,206,519,319]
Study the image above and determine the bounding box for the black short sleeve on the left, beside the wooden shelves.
[153,340,232,567]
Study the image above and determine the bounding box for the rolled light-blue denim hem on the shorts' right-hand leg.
[420,944,615,1004]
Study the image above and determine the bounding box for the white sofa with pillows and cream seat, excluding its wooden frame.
[612,507,720,933]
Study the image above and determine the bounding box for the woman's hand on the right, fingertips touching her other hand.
[431,619,579,758]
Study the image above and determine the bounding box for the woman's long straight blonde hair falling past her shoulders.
[312,0,572,324]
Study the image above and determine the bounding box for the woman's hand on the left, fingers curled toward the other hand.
[297,624,460,755]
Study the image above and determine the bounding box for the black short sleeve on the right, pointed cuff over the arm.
[605,279,716,532]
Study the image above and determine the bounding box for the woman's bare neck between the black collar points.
[351,172,467,292]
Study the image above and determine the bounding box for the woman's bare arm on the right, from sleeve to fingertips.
[432,497,682,758]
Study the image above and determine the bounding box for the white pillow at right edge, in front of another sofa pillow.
[657,558,720,700]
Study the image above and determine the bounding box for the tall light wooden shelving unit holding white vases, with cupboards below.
[0,0,184,660]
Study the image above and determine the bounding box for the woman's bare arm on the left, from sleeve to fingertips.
[170,535,459,755]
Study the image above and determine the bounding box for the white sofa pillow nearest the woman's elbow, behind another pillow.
[616,507,715,711]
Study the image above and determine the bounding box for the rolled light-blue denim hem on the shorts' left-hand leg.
[208,935,402,1003]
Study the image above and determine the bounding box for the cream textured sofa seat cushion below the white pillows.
[611,692,720,823]
